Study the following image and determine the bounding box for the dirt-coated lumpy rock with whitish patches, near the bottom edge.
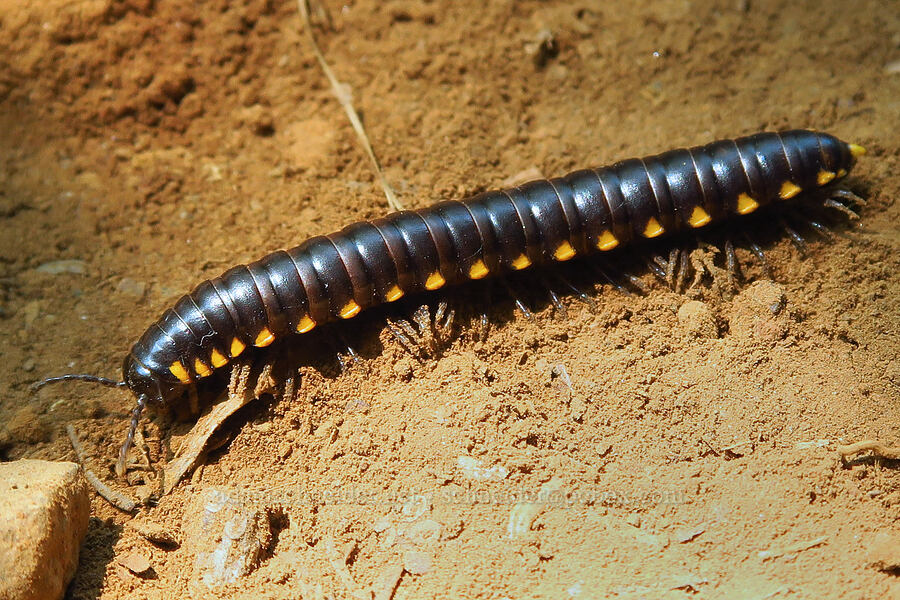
[182,487,272,592]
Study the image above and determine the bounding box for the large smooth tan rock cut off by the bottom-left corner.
[0,460,91,600]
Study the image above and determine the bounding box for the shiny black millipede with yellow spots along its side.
[36,130,865,475]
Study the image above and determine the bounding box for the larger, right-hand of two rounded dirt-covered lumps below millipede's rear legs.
[729,280,790,343]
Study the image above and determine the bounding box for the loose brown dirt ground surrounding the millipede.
[0,0,900,598]
